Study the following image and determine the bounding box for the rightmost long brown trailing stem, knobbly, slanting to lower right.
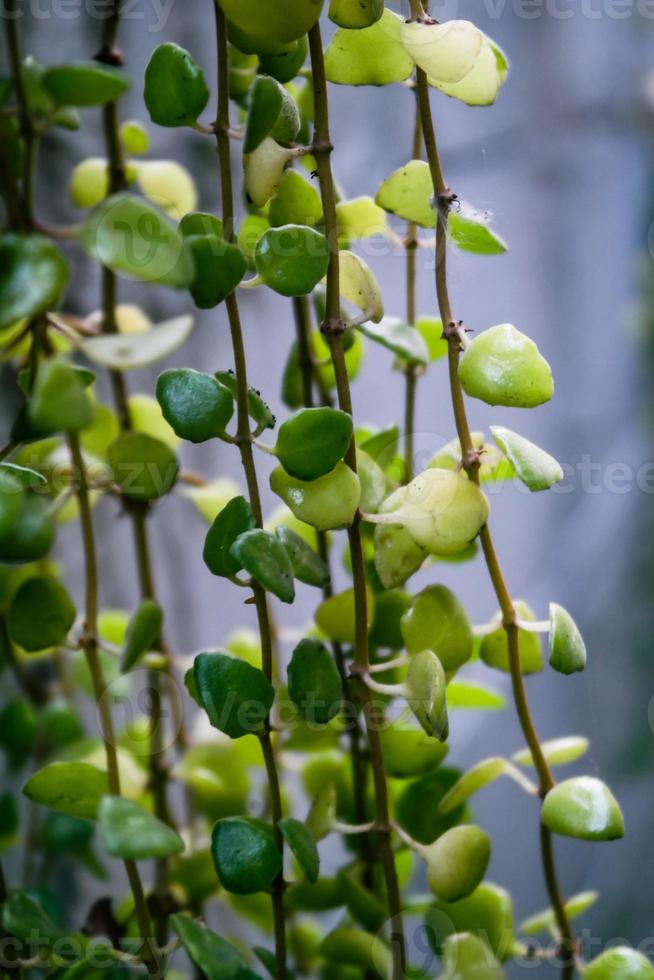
[411,0,575,980]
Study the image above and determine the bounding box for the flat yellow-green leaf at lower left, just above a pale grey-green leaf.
[23,762,109,820]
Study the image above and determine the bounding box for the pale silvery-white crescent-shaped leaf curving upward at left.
[79,316,194,371]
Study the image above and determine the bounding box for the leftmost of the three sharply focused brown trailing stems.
[214,2,287,980]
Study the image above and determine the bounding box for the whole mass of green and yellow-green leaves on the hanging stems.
[0,0,654,980]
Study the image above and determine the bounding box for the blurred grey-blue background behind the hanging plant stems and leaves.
[0,0,654,976]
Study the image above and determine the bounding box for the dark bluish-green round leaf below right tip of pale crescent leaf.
[157,368,234,443]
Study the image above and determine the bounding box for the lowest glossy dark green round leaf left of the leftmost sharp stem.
[211,817,282,895]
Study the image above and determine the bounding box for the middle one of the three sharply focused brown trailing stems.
[309,23,406,980]
